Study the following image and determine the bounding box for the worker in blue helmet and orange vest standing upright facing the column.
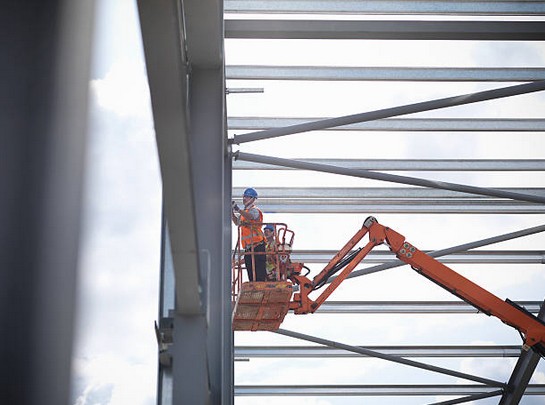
[231,188,267,281]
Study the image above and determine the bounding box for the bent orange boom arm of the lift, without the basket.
[290,217,545,351]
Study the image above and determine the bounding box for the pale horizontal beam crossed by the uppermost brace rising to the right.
[227,117,545,132]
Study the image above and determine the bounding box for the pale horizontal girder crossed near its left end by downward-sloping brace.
[233,158,545,170]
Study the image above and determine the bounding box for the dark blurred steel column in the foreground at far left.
[0,0,95,405]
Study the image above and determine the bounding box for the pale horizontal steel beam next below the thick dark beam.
[225,66,545,82]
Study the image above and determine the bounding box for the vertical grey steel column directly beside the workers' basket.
[189,66,233,404]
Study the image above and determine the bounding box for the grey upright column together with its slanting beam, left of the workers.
[138,0,233,404]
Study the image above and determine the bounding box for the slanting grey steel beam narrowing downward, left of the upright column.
[138,0,203,315]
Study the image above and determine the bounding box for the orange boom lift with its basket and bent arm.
[233,217,545,354]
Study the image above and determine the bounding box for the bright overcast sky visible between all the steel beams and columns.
[73,0,545,405]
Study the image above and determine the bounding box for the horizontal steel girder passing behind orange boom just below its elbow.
[291,250,545,264]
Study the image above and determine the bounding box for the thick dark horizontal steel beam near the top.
[225,19,545,41]
